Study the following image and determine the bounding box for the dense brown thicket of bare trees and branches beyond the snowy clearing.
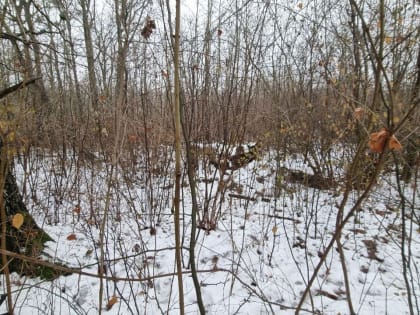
[1,1,418,160]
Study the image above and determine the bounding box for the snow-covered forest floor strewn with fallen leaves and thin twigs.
[0,150,420,315]
